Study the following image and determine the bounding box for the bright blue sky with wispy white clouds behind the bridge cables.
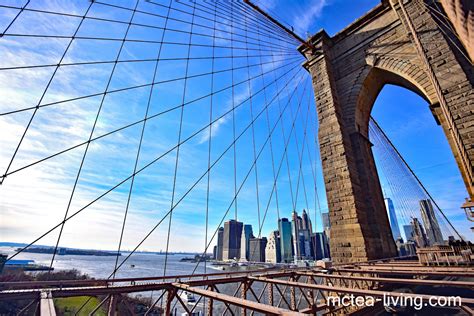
[0,0,472,266]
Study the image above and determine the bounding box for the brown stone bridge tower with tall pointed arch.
[300,0,474,263]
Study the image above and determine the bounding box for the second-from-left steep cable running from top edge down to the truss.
[113,0,174,278]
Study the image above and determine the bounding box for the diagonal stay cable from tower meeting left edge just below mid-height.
[0,57,297,178]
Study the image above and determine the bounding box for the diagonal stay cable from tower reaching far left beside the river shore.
[7,56,301,261]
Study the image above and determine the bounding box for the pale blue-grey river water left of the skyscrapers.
[0,247,218,279]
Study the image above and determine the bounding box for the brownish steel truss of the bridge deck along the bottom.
[0,260,474,315]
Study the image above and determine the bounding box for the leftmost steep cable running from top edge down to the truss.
[50,0,140,271]
